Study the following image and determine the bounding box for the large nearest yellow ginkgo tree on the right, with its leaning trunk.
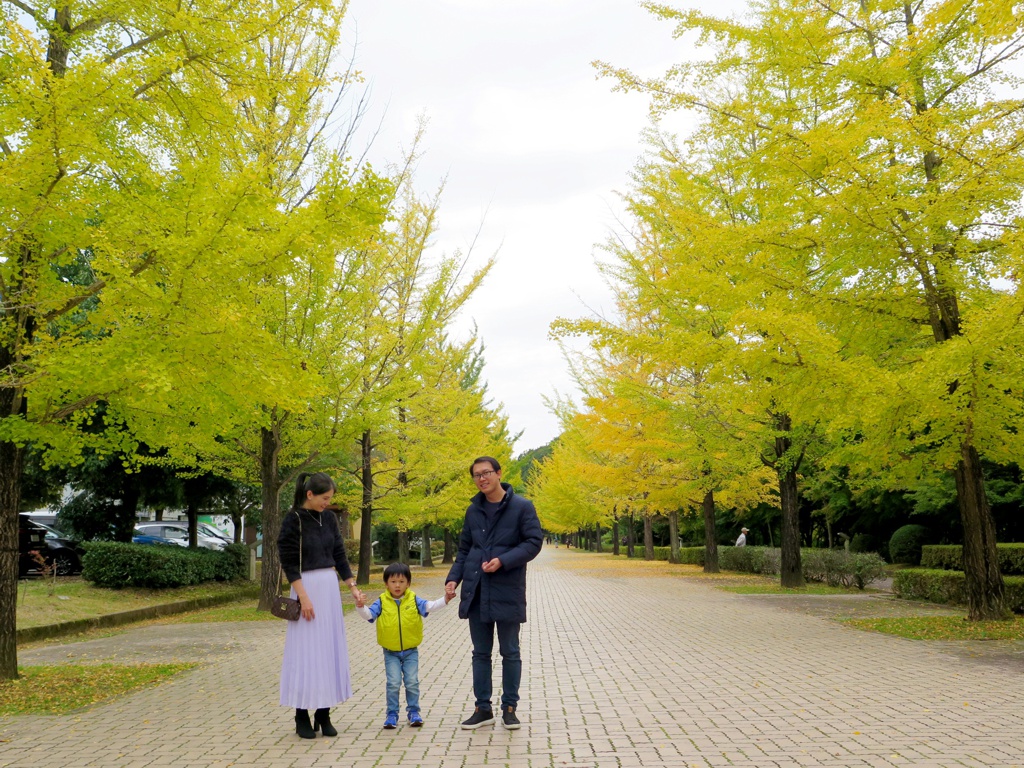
[605,0,1024,618]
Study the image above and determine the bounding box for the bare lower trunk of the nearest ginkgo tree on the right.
[953,442,1007,622]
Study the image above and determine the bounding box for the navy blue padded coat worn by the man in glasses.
[445,482,544,624]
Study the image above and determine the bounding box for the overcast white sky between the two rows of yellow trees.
[346,0,741,454]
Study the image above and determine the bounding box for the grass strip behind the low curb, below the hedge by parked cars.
[17,577,257,629]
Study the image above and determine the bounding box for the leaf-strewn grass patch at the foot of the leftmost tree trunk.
[0,664,196,715]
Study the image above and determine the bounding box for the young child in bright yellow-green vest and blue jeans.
[355,562,452,730]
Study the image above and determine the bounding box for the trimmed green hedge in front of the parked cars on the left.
[82,542,249,589]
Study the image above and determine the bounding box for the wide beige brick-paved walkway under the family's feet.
[0,548,1024,768]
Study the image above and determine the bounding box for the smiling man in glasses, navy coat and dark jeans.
[444,456,544,730]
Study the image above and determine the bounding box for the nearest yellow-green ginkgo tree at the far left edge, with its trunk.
[0,0,352,678]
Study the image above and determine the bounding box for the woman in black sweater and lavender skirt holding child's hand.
[278,472,366,738]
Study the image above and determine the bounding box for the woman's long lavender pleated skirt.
[281,568,352,710]
